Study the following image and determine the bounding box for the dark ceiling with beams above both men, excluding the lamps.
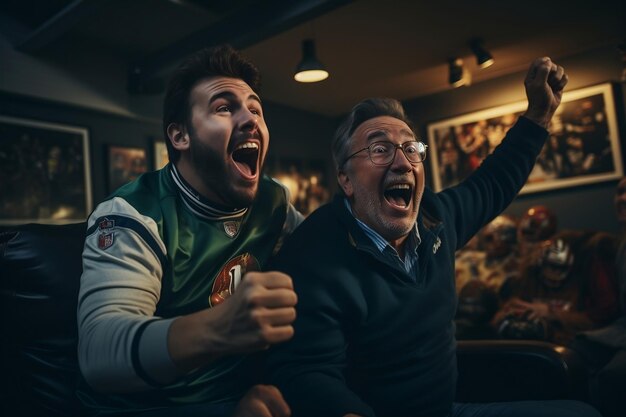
[0,0,626,116]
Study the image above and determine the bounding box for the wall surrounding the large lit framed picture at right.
[404,48,626,232]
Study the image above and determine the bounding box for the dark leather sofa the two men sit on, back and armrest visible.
[0,223,586,416]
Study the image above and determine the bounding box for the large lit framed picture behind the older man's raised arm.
[428,83,624,194]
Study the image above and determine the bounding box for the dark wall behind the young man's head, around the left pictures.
[0,92,334,210]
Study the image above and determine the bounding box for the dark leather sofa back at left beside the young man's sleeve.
[0,223,86,416]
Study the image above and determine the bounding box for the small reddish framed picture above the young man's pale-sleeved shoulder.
[107,145,148,193]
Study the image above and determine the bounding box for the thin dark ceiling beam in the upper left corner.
[14,0,109,53]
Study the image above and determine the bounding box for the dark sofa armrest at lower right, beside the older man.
[456,340,587,402]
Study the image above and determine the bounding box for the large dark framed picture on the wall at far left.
[0,115,91,224]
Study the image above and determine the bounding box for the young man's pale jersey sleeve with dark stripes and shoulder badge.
[77,198,180,392]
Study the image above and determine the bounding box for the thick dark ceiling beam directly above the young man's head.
[128,0,353,93]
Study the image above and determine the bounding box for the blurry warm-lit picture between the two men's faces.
[264,157,330,216]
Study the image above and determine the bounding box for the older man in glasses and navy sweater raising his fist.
[267,58,597,417]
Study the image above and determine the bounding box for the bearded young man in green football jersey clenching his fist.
[78,47,301,416]
